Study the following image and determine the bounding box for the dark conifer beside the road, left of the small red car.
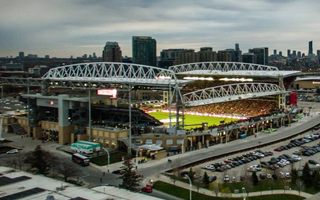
[119,159,142,191]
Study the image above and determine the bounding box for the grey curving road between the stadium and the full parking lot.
[138,115,320,177]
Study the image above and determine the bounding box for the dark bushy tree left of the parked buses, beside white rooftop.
[24,145,54,174]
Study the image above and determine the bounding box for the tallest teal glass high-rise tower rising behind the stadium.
[132,36,157,66]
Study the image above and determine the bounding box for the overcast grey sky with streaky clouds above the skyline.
[0,0,320,57]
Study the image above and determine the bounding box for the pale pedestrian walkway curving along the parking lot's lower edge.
[153,174,313,198]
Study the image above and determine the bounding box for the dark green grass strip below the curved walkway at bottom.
[154,181,303,200]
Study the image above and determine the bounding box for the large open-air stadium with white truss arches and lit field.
[1,62,301,156]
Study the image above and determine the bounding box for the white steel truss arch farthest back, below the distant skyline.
[169,62,279,73]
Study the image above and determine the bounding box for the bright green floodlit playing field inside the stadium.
[148,112,238,129]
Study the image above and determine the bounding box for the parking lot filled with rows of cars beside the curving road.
[186,126,320,182]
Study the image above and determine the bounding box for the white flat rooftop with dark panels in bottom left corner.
[0,166,159,200]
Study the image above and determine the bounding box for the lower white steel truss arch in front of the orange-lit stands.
[183,83,286,106]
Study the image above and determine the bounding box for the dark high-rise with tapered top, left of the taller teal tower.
[102,42,122,62]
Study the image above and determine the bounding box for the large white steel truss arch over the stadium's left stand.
[42,62,183,86]
